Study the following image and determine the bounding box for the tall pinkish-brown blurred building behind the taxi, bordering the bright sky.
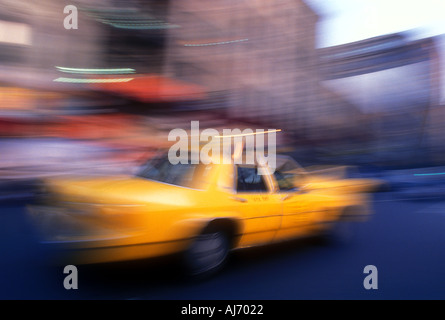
[161,0,319,134]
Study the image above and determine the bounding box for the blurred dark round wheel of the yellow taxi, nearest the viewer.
[183,229,230,278]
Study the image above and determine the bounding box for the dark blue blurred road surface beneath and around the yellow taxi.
[0,193,445,300]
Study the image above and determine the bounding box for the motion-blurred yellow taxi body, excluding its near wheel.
[29,157,379,274]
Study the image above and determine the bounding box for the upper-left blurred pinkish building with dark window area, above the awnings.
[0,0,174,80]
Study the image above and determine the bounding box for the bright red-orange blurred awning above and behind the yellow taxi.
[93,75,206,102]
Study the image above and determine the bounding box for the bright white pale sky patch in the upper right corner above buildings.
[305,0,445,47]
